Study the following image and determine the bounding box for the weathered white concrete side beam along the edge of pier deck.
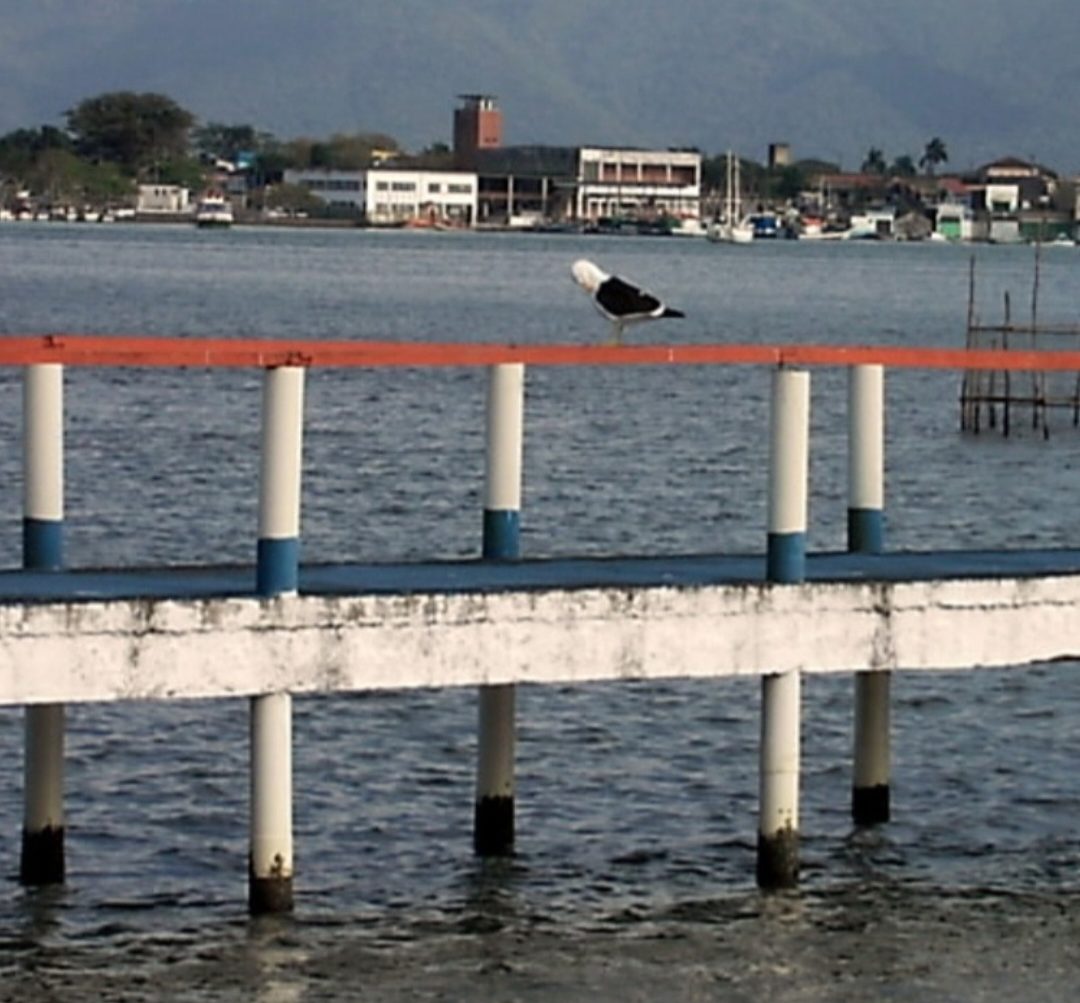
[0,575,1080,704]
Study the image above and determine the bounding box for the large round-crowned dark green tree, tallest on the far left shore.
[66,91,194,177]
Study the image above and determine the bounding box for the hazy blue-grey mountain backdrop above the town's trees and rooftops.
[0,0,1080,175]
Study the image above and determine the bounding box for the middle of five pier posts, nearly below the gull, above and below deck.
[473,363,525,856]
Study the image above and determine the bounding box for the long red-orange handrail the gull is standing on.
[0,334,1080,371]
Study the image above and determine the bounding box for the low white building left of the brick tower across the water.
[284,167,477,227]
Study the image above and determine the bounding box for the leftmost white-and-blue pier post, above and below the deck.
[18,364,65,885]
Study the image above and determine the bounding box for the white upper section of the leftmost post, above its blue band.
[23,364,64,521]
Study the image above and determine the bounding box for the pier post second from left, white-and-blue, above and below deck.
[248,366,303,913]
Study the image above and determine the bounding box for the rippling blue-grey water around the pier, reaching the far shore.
[0,225,1080,1003]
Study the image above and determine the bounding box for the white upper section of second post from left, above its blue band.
[258,366,303,540]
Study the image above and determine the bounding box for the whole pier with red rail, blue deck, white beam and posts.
[0,335,1080,913]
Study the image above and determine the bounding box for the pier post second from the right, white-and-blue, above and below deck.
[757,368,810,889]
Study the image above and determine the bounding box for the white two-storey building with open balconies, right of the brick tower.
[576,147,701,219]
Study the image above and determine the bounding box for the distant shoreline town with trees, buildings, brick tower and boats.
[0,92,1078,243]
